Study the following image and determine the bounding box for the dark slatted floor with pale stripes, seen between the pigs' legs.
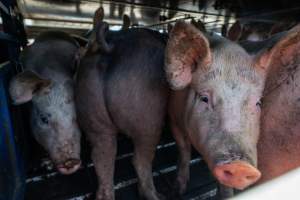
[25,130,216,200]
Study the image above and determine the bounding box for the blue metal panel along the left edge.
[0,65,25,200]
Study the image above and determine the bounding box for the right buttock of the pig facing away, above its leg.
[105,29,168,136]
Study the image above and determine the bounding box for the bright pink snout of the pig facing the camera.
[213,161,261,190]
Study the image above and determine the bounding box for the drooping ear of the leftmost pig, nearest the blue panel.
[9,71,51,105]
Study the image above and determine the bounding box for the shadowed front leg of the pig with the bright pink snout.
[172,126,191,194]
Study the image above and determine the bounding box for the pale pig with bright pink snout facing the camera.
[165,22,300,195]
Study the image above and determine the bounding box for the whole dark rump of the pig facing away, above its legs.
[76,29,168,136]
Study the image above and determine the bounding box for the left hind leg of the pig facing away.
[91,128,117,200]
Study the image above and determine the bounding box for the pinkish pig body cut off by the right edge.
[243,25,300,184]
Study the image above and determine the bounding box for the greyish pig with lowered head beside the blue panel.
[9,31,81,174]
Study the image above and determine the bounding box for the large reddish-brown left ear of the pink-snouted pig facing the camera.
[165,22,211,89]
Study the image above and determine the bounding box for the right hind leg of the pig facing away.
[133,134,163,200]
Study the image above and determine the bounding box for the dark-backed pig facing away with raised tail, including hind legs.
[75,9,168,200]
